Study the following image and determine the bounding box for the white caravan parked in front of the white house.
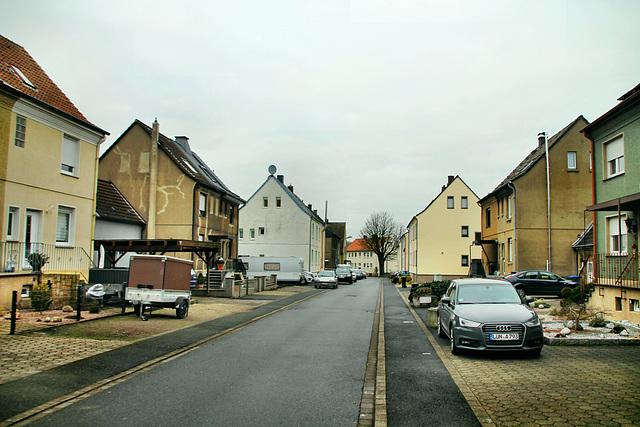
[238,256,307,285]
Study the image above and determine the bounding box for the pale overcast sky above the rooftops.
[0,0,640,237]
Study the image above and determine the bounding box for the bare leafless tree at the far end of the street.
[360,212,404,275]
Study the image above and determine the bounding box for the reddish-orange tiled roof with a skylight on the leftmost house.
[0,35,108,133]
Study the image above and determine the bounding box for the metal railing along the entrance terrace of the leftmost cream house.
[0,242,94,273]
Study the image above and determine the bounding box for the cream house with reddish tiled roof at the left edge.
[0,36,108,308]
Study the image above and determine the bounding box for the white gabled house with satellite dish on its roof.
[238,175,325,272]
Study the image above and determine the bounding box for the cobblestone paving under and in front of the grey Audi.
[400,291,640,427]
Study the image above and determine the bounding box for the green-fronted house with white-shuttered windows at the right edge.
[582,85,640,323]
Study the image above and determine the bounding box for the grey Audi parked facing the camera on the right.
[438,279,543,356]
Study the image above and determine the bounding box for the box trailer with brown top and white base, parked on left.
[125,255,193,320]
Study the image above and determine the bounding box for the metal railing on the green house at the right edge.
[593,252,640,288]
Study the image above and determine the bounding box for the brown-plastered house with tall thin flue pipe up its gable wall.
[477,116,592,276]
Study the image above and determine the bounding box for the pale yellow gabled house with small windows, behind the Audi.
[404,176,480,283]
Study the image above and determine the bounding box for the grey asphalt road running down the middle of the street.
[33,278,380,426]
